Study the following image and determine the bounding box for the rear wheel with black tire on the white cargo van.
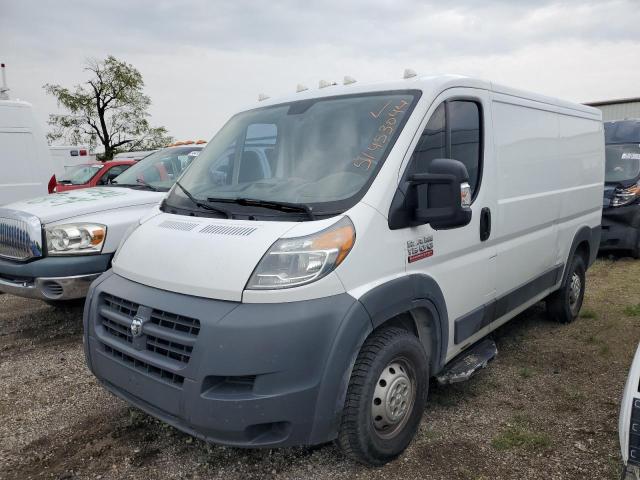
[546,255,586,323]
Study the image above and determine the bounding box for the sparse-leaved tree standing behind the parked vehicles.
[43,55,173,160]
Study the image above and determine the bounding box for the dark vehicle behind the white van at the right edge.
[600,120,640,258]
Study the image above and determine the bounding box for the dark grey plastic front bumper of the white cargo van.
[84,271,372,447]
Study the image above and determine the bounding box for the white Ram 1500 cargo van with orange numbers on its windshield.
[84,76,604,465]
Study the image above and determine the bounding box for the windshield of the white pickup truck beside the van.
[113,145,202,192]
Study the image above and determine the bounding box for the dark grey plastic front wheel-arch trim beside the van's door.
[360,274,449,375]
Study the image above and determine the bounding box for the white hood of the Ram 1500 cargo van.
[113,214,299,302]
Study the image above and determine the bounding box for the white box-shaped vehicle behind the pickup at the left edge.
[0,63,56,205]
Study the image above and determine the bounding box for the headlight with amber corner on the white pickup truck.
[45,223,107,255]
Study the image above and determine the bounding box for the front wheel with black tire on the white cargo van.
[336,327,429,466]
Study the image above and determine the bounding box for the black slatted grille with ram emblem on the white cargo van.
[99,294,200,368]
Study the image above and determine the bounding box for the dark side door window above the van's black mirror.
[409,100,482,195]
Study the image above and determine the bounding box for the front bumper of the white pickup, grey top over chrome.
[0,254,112,300]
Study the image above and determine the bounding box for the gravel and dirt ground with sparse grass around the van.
[0,259,640,480]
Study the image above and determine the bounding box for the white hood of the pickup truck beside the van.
[3,187,166,224]
